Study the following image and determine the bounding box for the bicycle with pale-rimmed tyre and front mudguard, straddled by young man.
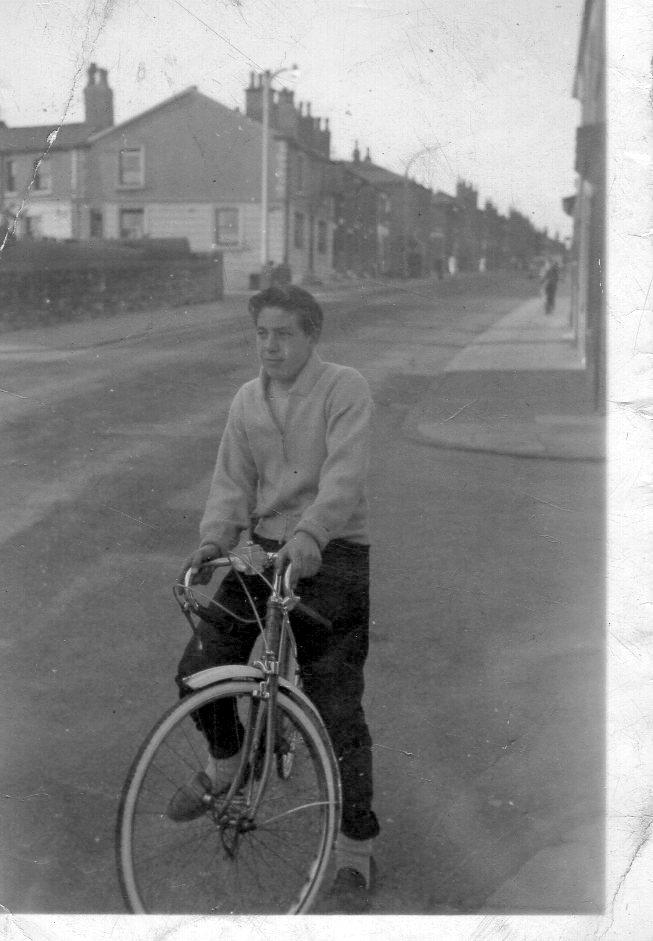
[117,545,341,915]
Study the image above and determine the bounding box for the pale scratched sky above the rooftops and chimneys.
[0,0,583,236]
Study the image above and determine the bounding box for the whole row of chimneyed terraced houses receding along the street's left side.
[0,64,560,292]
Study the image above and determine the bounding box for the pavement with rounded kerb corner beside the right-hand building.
[404,296,605,461]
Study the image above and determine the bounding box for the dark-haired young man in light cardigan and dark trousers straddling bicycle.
[173,285,379,912]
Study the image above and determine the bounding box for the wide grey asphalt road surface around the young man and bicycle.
[0,278,603,914]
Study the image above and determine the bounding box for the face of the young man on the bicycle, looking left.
[256,307,315,388]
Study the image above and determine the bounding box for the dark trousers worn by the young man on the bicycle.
[176,539,379,840]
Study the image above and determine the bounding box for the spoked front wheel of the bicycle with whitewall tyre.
[117,680,340,915]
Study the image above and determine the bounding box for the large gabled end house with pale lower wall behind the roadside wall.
[0,65,332,291]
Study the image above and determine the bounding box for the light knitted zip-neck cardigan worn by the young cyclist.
[200,351,373,552]
